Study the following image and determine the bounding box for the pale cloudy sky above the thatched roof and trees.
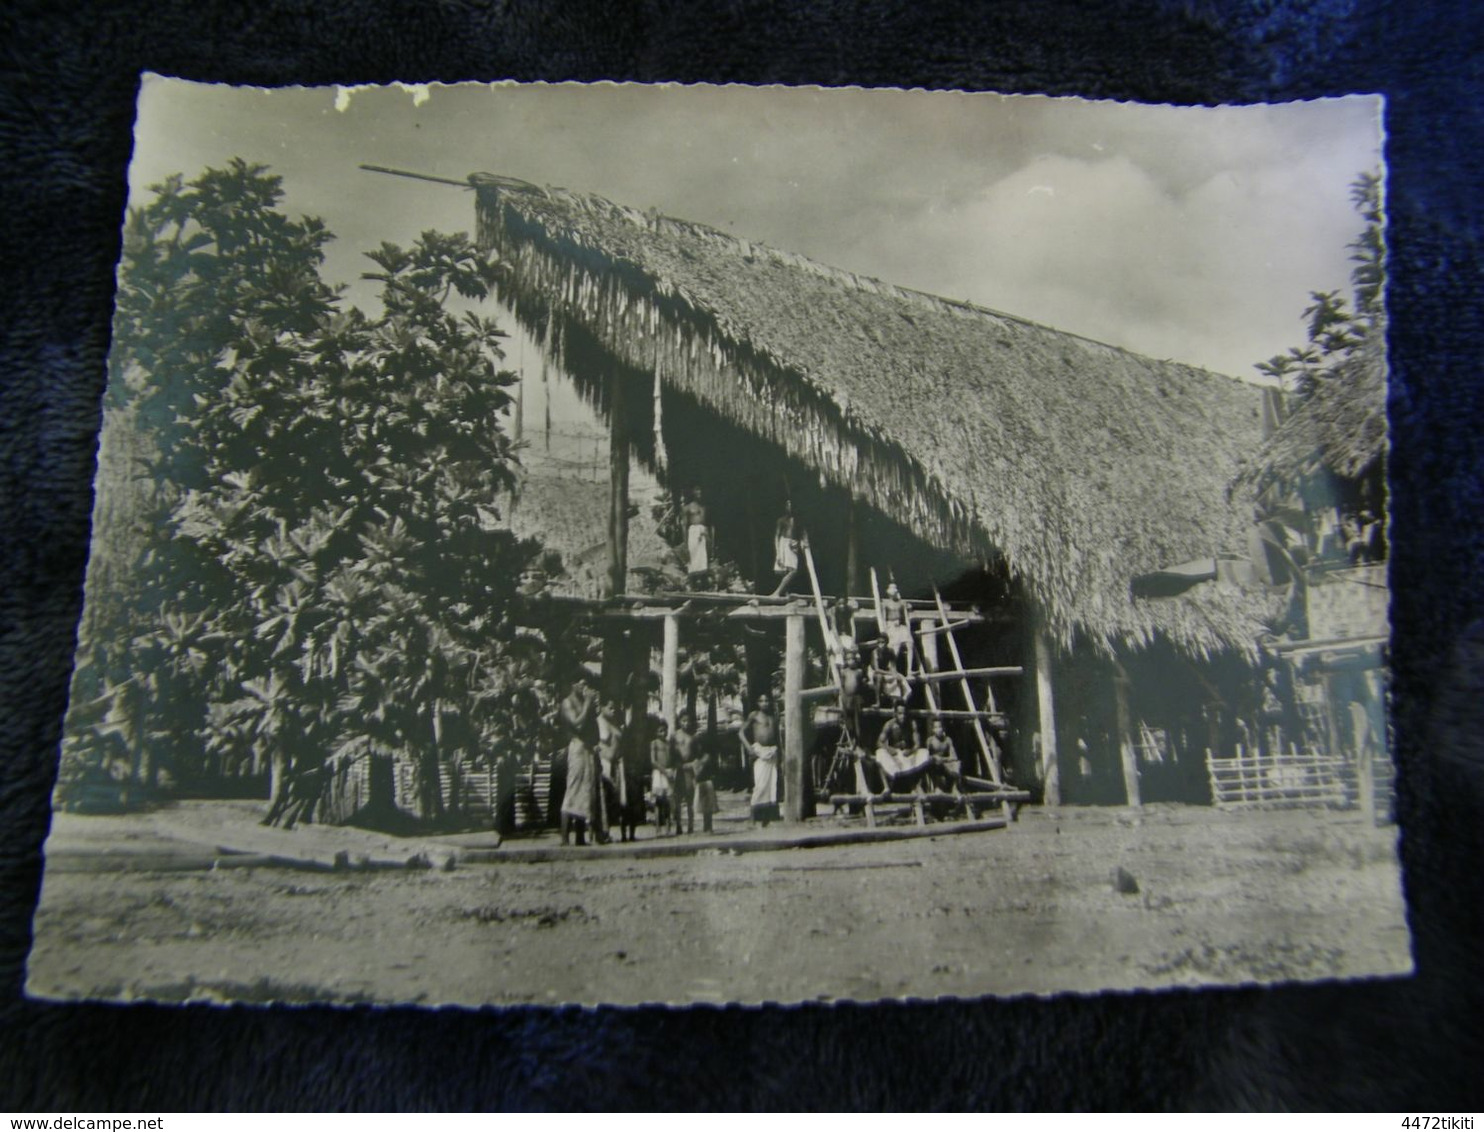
[129,76,1382,380]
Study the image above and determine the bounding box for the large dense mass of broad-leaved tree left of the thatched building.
[68,162,543,817]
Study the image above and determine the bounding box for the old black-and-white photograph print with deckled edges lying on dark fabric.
[27,76,1411,1006]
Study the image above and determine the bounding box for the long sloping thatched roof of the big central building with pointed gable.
[469,174,1266,654]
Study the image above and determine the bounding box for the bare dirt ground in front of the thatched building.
[28,806,1411,1004]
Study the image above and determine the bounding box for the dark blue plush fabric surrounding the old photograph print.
[0,0,1484,1111]
